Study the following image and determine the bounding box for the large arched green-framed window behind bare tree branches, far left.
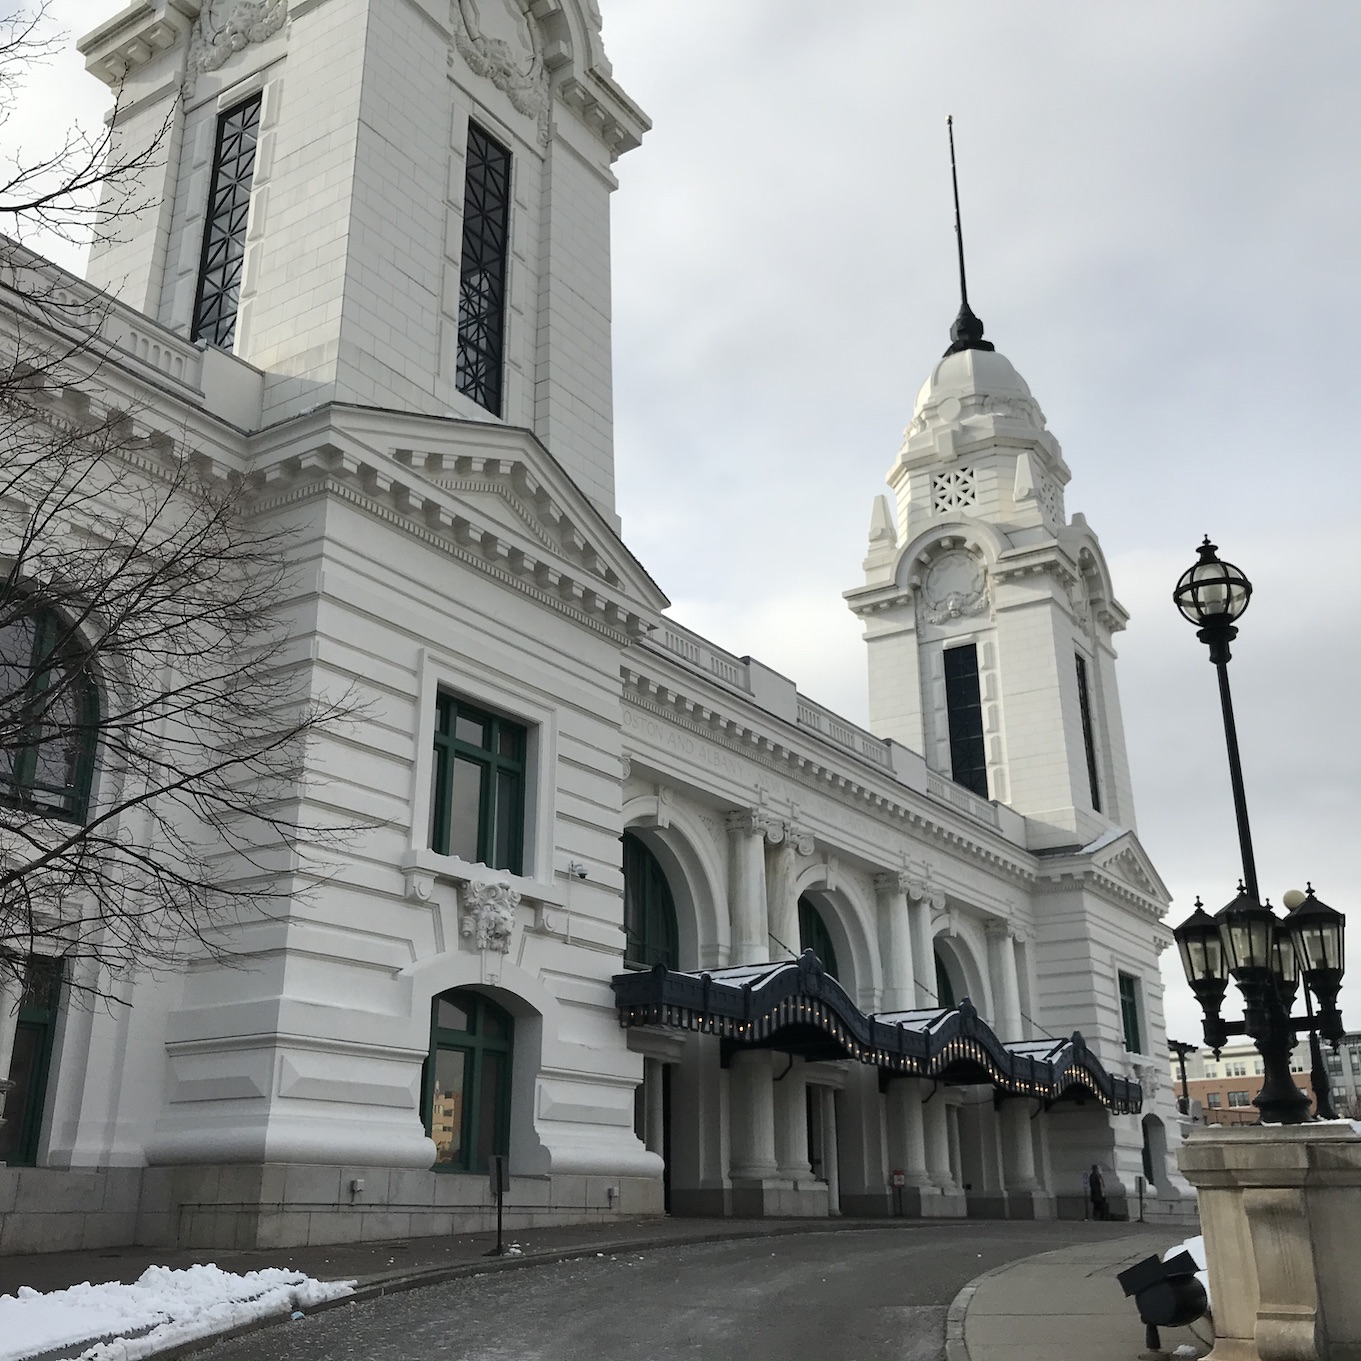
[0,607,99,822]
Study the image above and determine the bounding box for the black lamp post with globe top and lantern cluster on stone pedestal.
[1173,538,1345,1124]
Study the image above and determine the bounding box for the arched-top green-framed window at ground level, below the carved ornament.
[423,988,514,1172]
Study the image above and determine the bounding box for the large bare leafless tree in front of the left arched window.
[0,382,348,989]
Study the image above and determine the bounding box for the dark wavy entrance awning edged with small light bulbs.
[612,950,1143,1115]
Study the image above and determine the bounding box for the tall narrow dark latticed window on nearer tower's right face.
[456,122,510,416]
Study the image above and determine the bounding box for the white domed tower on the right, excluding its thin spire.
[847,302,1134,848]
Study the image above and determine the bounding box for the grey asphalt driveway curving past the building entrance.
[204,1219,1170,1361]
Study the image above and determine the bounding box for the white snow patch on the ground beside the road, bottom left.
[0,1266,354,1361]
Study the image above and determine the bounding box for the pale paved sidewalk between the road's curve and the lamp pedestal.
[946,1229,1213,1361]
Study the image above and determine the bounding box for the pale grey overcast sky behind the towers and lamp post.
[18,0,1361,1041]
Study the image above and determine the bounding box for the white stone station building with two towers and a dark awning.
[0,0,1187,1251]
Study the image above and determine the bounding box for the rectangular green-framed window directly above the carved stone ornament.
[430,694,527,874]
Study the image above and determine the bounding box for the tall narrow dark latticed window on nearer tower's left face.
[193,95,260,350]
